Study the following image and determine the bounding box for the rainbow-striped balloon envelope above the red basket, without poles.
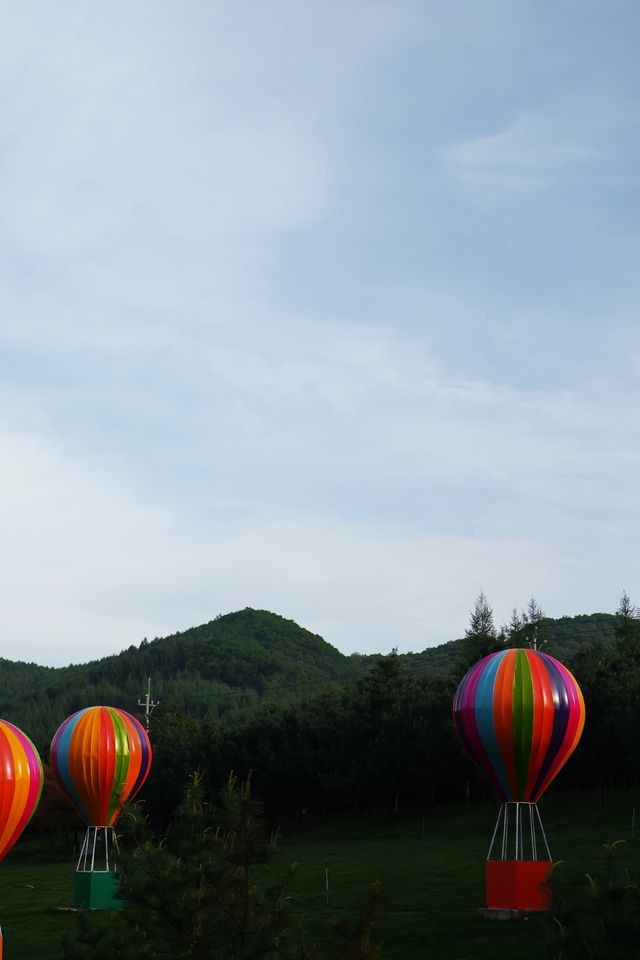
[453,650,585,803]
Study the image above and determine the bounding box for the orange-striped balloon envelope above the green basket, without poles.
[51,707,151,827]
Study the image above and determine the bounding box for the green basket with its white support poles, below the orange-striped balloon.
[75,827,122,912]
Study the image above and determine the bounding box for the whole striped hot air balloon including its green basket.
[51,706,151,908]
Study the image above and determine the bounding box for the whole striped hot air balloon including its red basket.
[453,650,585,909]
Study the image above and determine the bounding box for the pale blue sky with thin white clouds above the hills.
[0,0,640,665]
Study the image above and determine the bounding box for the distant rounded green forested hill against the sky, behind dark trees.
[0,608,616,748]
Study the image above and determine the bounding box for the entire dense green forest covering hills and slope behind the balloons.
[5,595,640,823]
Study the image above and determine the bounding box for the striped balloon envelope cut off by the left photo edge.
[0,720,44,860]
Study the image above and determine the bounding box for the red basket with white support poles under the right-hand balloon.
[486,803,552,911]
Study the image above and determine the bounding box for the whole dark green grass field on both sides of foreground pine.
[0,793,640,960]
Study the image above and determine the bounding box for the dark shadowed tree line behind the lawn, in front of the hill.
[129,594,640,822]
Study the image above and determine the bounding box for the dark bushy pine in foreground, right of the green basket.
[65,773,285,960]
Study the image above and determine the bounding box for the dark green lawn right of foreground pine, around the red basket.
[272,793,640,960]
